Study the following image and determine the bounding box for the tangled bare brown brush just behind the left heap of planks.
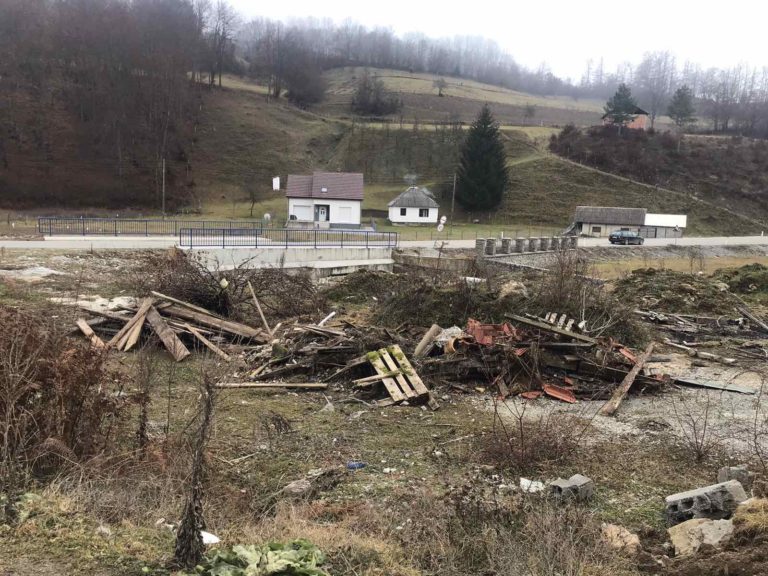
[127,248,324,321]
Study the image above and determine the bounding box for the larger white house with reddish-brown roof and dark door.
[285,172,363,228]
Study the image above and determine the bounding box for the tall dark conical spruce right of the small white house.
[456,104,509,210]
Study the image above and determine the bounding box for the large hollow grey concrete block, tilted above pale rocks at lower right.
[664,480,747,526]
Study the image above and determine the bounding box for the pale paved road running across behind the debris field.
[0,236,768,250]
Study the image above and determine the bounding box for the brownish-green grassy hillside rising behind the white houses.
[0,69,759,234]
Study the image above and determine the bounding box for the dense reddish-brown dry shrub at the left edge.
[0,309,120,478]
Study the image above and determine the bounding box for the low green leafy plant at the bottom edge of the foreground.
[197,540,328,576]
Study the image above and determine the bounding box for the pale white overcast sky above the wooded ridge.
[230,0,768,80]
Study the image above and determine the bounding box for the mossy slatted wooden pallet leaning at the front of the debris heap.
[368,344,439,410]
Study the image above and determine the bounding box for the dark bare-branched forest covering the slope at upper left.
[0,0,236,206]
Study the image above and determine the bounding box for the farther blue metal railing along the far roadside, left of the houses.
[37,217,271,236]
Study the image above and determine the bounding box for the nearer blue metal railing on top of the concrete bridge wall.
[179,228,399,248]
